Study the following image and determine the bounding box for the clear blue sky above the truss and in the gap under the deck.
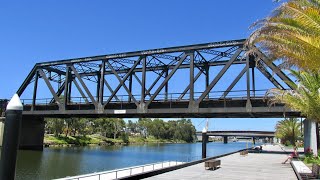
[0,0,279,130]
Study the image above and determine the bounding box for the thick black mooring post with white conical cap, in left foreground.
[0,94,23,180]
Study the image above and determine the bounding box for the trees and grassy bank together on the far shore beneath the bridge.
[44,118,197,147]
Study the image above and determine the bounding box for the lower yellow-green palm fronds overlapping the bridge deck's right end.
[267,70,320,123]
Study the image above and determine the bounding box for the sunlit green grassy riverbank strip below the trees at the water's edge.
[44,134,186,147]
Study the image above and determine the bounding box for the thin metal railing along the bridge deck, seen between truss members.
[21,89,268,105]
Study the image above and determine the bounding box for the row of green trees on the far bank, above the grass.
[45,117,196,142]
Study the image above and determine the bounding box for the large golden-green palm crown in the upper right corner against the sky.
[247,0,320,71]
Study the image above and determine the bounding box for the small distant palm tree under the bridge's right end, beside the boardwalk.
[276,118,301,145]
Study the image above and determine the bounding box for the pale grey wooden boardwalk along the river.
[148,145,297,180]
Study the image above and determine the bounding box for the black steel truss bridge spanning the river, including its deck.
[17,39,300,118]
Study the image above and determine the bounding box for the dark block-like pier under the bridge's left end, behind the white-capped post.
[19,116,45,151]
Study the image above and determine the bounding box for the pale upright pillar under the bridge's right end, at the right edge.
[303,119,318,155]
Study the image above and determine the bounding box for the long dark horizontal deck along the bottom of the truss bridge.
[23,99,300,118]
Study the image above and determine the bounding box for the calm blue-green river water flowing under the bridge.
[16,142,255,180]
